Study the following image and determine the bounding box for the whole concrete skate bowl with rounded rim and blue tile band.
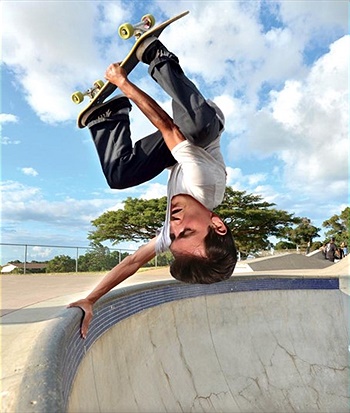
[17,277,349,413]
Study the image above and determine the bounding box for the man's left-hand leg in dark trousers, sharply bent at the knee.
[88,97,176,189]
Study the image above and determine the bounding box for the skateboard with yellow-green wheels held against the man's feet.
[72,11,189,129]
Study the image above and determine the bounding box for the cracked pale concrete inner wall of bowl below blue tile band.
[68,290,350,413]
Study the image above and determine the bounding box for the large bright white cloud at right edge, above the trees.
[230,36,350,201]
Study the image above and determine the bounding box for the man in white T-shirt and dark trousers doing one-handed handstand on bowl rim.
[70,37,237,337]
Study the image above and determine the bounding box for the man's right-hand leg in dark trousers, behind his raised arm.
[142,40,223,147]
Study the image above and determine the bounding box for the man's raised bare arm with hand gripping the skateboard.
[106,63,185,150]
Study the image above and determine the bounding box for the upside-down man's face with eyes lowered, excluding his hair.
[170,195,224,257]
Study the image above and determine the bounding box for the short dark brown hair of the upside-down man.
[170,224,237,284]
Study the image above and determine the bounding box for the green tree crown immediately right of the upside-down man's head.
[215,187,298,256]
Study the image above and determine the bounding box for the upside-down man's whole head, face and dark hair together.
[170,195,237,284]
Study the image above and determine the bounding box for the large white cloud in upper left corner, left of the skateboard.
[2,1,128,123]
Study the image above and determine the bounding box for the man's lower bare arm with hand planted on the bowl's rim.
[68,238,156,338]
